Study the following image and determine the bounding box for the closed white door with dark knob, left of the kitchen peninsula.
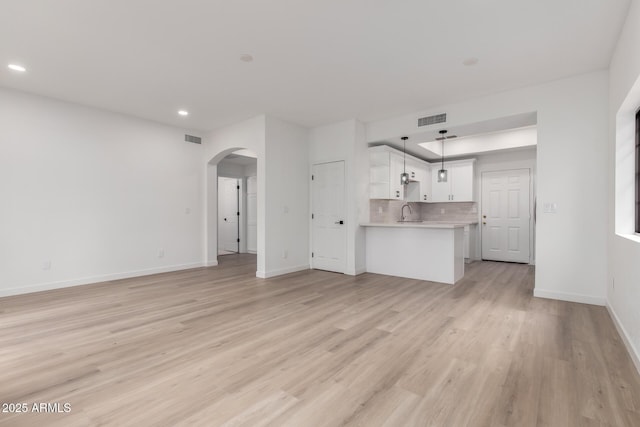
[311,161,344,273]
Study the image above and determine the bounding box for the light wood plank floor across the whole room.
[0,255,640,427]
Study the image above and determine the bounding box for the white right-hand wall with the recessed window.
[607,1,640,371]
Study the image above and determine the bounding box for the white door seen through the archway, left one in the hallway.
[218,177,240,252]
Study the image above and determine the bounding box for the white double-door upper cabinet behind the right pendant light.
[430,159,475,202]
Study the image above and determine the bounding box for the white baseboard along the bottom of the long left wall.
[0,262,204,297]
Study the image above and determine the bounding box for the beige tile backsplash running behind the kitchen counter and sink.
[369,199,478,222]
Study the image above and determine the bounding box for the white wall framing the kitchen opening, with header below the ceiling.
[366,71,608,304]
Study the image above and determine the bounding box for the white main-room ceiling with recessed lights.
[0,0,630,130]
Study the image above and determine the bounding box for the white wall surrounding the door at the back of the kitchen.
[474,149,537,264]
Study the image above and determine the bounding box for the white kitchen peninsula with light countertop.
[361,221,468,284]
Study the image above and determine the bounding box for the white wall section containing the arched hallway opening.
[204,115,267,274]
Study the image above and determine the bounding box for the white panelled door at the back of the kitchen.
[482,169,531,263]
